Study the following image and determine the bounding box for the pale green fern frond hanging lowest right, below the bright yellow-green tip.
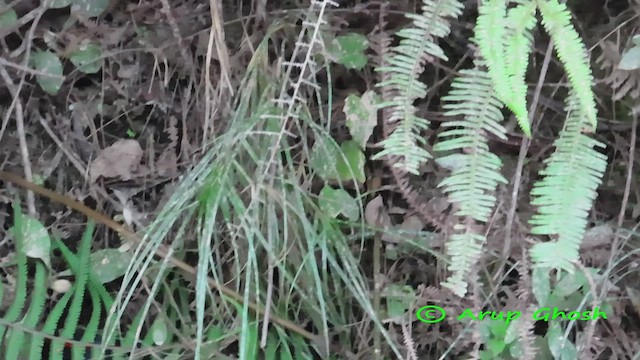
[529,92,607,272]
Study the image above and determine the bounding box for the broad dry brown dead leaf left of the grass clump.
[90,139,143,182]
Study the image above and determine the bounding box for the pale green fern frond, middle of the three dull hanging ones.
[434,67,507,296]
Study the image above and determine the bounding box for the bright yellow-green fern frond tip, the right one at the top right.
[538,0,597,130]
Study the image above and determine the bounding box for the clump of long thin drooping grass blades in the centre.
[103,20,400,359]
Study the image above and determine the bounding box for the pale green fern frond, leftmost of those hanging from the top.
[374,0,463,174]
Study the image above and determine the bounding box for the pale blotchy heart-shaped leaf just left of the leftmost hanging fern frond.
[343,90,380,149]
